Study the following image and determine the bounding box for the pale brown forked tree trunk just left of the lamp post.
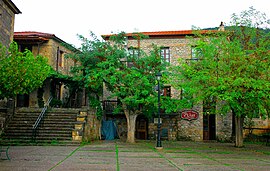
[125,111,138,143]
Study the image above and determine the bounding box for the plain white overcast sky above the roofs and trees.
[12,0,270,47]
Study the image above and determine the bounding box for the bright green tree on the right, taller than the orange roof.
[173,7,270,147]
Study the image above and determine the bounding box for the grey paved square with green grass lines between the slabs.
[0,140,270,171]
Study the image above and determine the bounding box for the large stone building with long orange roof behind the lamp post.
[103,30,233,141]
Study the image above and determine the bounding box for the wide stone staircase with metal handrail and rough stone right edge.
[1,108,86,145]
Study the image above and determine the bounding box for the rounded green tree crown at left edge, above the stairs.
[0,42,51,98]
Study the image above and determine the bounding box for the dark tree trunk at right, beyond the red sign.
[235,116,244,147]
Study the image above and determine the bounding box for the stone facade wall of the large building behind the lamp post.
[127,36,232,141]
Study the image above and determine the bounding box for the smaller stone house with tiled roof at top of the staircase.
[14,32,85,107]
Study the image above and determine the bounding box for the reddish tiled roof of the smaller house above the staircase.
[13,31,78,51]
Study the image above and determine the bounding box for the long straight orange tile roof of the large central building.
[102,30,215,40]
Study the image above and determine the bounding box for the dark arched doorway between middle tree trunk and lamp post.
[135,115,148,140]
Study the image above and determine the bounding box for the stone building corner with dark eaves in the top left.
[0,0,21,47]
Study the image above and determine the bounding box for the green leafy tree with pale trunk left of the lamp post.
[68,33,165,143]
